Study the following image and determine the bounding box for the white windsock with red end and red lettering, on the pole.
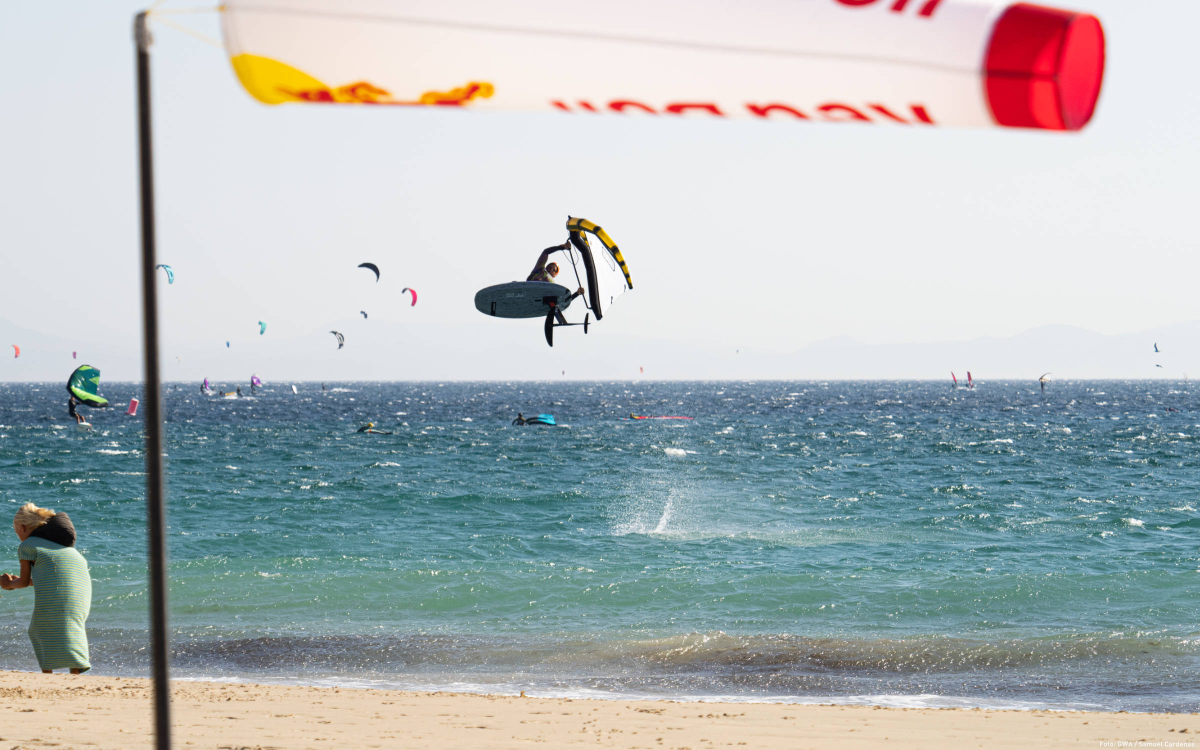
[222,0,1105,131]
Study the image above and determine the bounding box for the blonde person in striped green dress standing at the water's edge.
[0,503,91,674]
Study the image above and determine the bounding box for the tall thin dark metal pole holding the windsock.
[133,11,170,750]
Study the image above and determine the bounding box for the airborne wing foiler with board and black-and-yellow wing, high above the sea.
[475,217,634,346]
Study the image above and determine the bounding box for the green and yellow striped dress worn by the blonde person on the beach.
[17,536,91,672]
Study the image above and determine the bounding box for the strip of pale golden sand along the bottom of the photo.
[0,672,1200,750]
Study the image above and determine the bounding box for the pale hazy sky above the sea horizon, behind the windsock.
[0,0,1200,380]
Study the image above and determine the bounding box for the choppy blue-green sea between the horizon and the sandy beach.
[0,382,1200,712]
